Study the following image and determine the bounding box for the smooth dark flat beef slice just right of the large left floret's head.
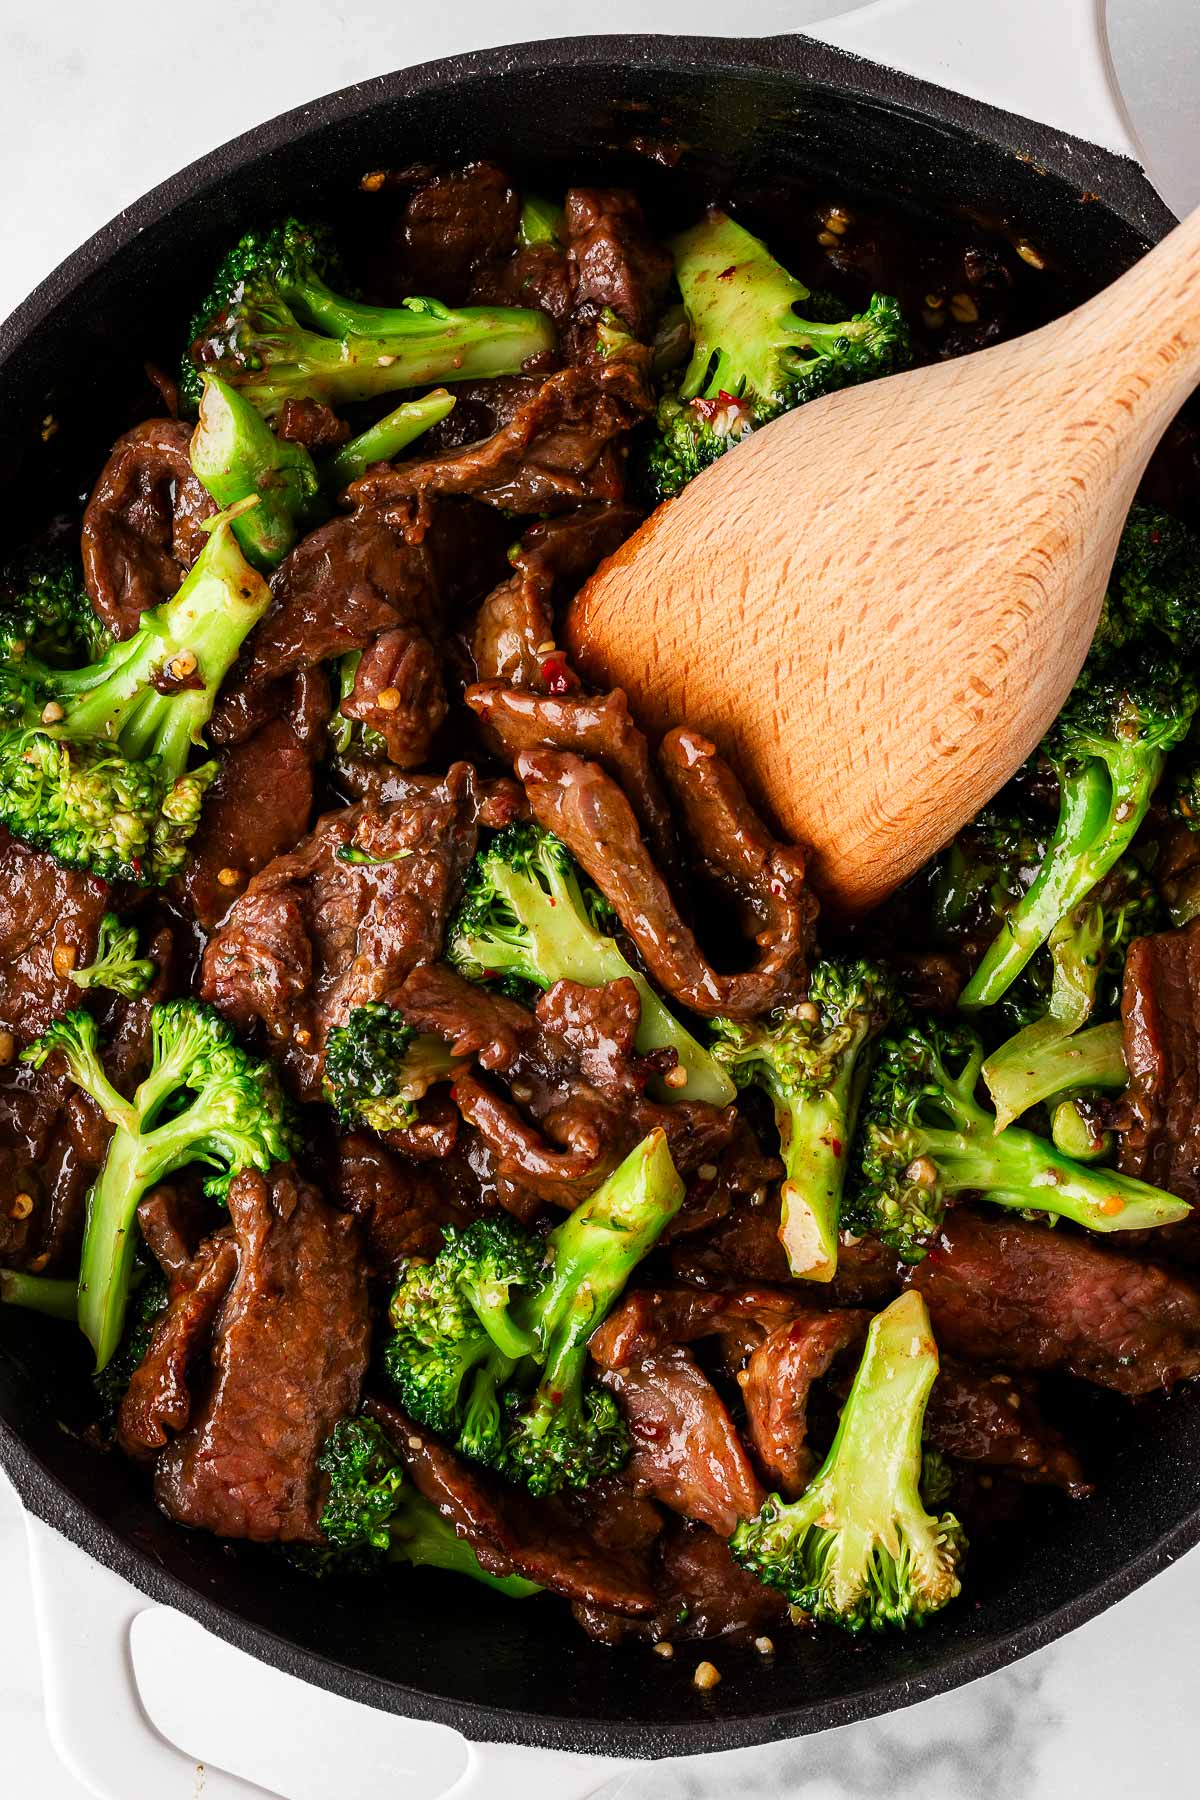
[180,718,315,931]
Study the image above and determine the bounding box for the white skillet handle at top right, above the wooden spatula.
[806,0,1146,162]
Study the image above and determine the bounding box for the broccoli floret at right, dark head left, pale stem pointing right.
[844,1021,1191,1262]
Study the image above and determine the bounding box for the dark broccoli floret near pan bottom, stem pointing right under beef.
[302,1418,542,1600]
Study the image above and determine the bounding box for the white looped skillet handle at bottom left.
[25,1512,624,1800]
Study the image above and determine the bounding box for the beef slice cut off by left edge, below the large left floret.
[0,828,110,1049]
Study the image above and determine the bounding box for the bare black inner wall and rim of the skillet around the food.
[0,38,1200,1757]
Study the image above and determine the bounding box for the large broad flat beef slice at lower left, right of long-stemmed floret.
[155,1166,371,1543]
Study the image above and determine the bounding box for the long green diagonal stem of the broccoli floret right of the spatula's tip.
[959,745,1162,1012]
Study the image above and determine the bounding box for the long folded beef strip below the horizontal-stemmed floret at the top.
[347,353,655,518]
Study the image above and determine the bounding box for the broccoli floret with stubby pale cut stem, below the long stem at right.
[982,857,1162,1129]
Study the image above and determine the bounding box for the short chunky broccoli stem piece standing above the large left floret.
[191,374,320,572]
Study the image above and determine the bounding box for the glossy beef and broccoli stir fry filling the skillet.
[0,164,1200,1648]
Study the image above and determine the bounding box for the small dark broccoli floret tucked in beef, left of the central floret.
[326,1001,462,1130]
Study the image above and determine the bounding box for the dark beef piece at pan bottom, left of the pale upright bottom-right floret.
[572,1519,788,1645]
